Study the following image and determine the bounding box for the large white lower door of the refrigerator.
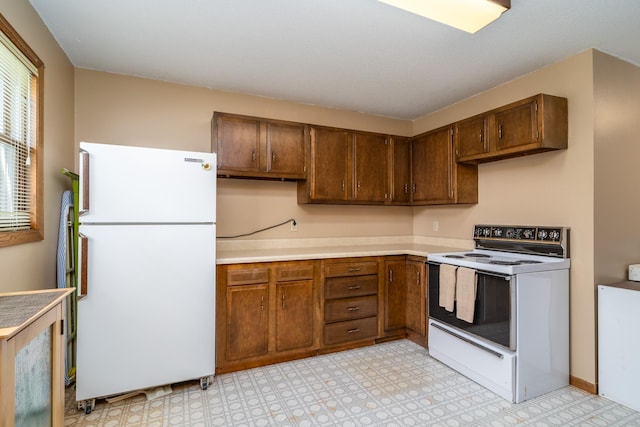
[76,225,216,401]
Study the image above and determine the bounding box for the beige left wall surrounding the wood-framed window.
[0,0,74,292]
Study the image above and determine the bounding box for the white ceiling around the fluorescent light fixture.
[30,0,640,120]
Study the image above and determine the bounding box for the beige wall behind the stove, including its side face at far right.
[414,50,640,384]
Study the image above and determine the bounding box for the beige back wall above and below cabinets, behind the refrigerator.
[76,70,412,239]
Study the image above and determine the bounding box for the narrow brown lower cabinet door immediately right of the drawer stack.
[384,259,406,331]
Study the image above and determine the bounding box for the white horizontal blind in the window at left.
[0,33,38,232]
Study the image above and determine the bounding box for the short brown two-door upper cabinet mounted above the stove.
[455,94,568,163]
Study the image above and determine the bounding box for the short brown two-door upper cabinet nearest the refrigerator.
[212,112,306,180]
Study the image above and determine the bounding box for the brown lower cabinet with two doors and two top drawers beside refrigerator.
[216,261,319,373]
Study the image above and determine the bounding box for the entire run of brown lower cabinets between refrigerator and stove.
[216,255,427,373]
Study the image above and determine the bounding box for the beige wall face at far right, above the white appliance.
[594,52,640,284]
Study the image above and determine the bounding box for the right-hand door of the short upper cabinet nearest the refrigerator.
[266,121,306,179]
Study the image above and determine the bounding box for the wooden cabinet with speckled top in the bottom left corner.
[0,288,75,427]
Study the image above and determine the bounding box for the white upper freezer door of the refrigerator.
[80,142,216,223]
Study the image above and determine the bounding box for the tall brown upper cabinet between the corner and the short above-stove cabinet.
[411,126,478,205]
